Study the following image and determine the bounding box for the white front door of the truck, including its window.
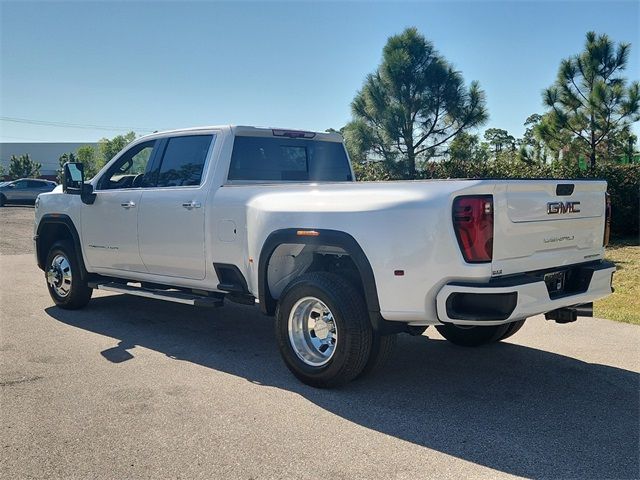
[82,140,157,272]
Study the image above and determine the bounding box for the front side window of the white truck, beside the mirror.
[100,140,156,190]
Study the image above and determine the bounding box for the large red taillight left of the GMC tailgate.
[453,195,493,263]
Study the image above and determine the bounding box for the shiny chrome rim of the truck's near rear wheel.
[289,297,338,367]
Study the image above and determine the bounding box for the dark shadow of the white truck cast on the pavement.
[46,295,640,479]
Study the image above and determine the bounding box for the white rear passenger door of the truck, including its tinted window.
[138,134,214,280]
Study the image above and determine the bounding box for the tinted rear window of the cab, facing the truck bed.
[228,137,351,182]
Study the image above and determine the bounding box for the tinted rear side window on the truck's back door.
[157,135,213,187]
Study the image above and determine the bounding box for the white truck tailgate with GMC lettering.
[492,180,607,275]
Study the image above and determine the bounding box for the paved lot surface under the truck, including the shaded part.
[0,207,640,479]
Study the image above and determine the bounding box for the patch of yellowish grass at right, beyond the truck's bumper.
[593,239,640,325]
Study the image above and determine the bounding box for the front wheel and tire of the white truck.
[45,240,93,310]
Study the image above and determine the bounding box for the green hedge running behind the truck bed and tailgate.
[354,159,640,238]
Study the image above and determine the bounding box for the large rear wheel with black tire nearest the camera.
[275,272,373,388]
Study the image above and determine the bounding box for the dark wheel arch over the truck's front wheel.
[35,214,87,280]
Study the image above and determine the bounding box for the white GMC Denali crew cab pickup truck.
[34,126,615,387]
